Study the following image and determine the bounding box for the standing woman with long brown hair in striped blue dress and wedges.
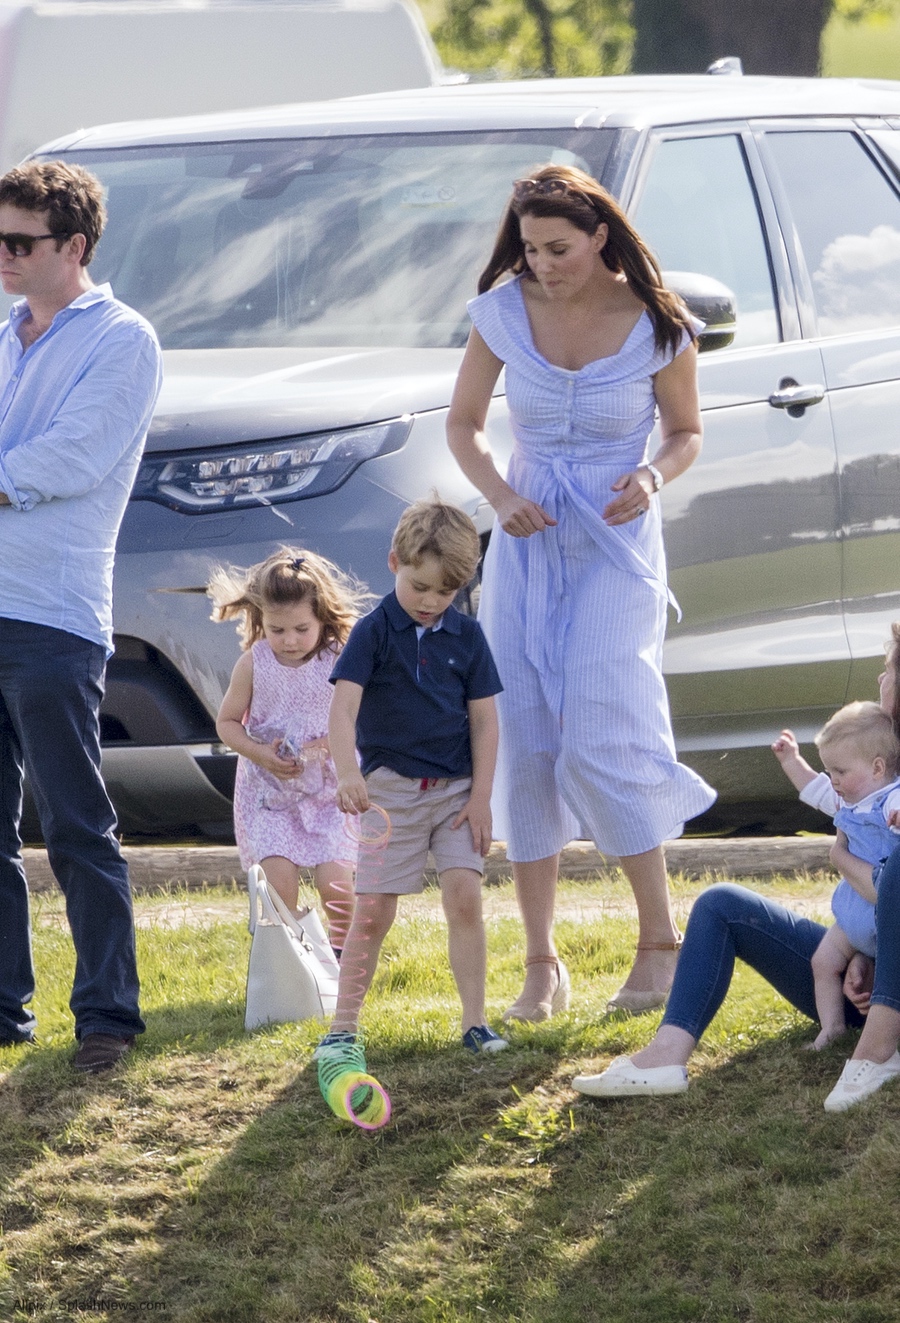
[447,165,715,1020]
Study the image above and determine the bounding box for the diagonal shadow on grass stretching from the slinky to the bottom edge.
[99,1050,569,1323]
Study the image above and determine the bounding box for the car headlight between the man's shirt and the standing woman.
[131,417,412,515]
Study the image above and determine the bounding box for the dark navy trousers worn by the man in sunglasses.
[0,619,144,1040]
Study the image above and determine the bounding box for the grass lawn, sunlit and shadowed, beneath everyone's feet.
[0,877,900,1323]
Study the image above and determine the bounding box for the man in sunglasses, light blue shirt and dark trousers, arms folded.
[0,161,161,1073]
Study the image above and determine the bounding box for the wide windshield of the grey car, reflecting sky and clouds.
[57,128,614,349]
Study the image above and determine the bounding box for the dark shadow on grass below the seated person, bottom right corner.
[481,1029,900,1323]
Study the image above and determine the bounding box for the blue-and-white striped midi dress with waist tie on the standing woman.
[469,279,715,863]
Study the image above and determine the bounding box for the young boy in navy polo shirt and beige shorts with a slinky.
[316,500,507,1070]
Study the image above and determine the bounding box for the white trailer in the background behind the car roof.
[0,0,443,171]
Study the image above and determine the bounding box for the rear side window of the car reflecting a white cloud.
[766,130,900,336]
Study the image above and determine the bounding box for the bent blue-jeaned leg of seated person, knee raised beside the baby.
[663,878,868,1039]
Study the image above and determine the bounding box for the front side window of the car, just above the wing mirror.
[634,134,780,347]
